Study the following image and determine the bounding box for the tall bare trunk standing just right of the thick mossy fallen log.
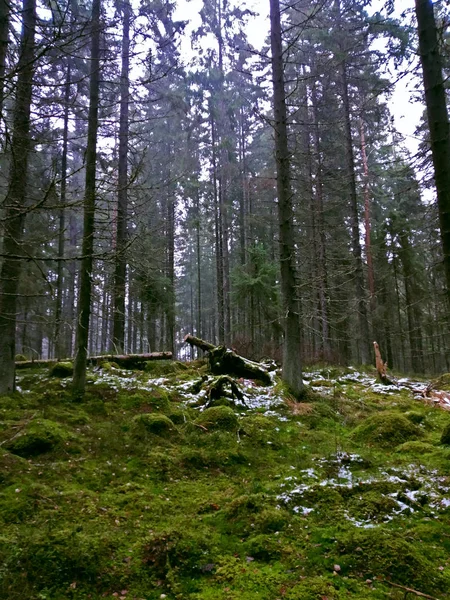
[270,0,303,395]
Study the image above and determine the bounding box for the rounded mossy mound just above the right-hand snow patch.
[351,412,422,447]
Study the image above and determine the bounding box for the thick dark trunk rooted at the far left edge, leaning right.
[0,0,36,394]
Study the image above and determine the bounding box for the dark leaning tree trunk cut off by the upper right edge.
[416,0,450,308]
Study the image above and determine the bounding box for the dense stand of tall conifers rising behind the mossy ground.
[0,0,450,394]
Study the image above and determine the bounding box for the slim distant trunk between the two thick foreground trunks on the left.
[55,58,71,358]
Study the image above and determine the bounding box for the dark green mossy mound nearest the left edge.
[4,419,73,458]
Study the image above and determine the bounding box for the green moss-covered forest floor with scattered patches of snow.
[0,361,450,600]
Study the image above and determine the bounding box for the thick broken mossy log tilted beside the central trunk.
[184,335,272,385]
